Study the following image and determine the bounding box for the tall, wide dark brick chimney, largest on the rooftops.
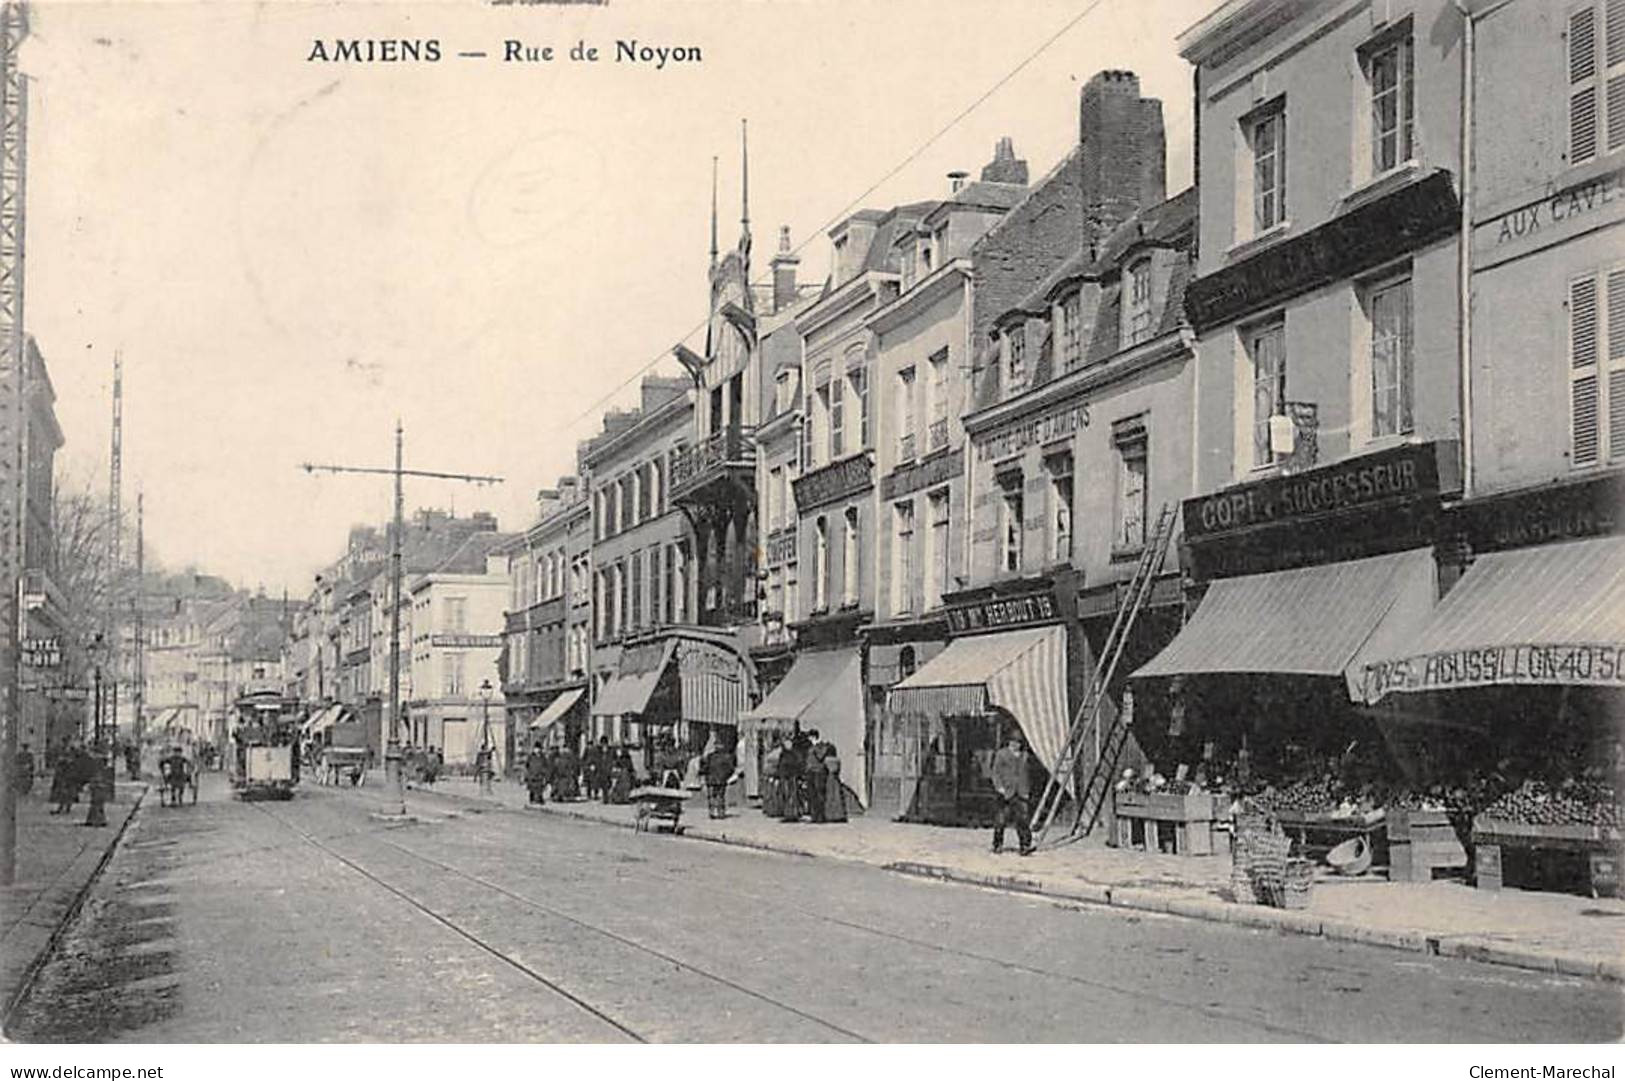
[1077,72,1168,244]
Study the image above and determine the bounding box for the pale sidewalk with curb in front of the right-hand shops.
[416,777,1625,982]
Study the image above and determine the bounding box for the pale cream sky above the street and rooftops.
[24,0,1212,597]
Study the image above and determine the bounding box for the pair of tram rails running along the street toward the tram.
[255,805,876,1044]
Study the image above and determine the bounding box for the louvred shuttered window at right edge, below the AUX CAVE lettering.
[1568,267,1625,467]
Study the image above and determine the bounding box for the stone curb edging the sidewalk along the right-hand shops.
[429,792,1625,983]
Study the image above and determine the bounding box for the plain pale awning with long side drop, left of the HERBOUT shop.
[739,649,869,801]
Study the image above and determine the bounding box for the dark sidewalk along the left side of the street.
[0,777,146,1018]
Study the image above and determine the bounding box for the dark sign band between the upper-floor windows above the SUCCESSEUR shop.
[1185,169,1461,333]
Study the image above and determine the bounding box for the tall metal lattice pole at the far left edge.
[0,3,28,886]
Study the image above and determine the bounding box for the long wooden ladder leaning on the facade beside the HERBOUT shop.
[1032,504,1178,844]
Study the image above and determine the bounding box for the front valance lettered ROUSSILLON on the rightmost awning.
[1363,644,1625,702]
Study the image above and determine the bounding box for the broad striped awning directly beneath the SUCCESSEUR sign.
[1134,548,1438,701]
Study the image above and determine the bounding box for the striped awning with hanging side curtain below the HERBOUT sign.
[887,626,1066,769]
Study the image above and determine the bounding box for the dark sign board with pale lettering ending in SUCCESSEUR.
[1183,444,1441,541]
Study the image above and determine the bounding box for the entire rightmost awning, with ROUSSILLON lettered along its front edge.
[1363,536,1625,702]
